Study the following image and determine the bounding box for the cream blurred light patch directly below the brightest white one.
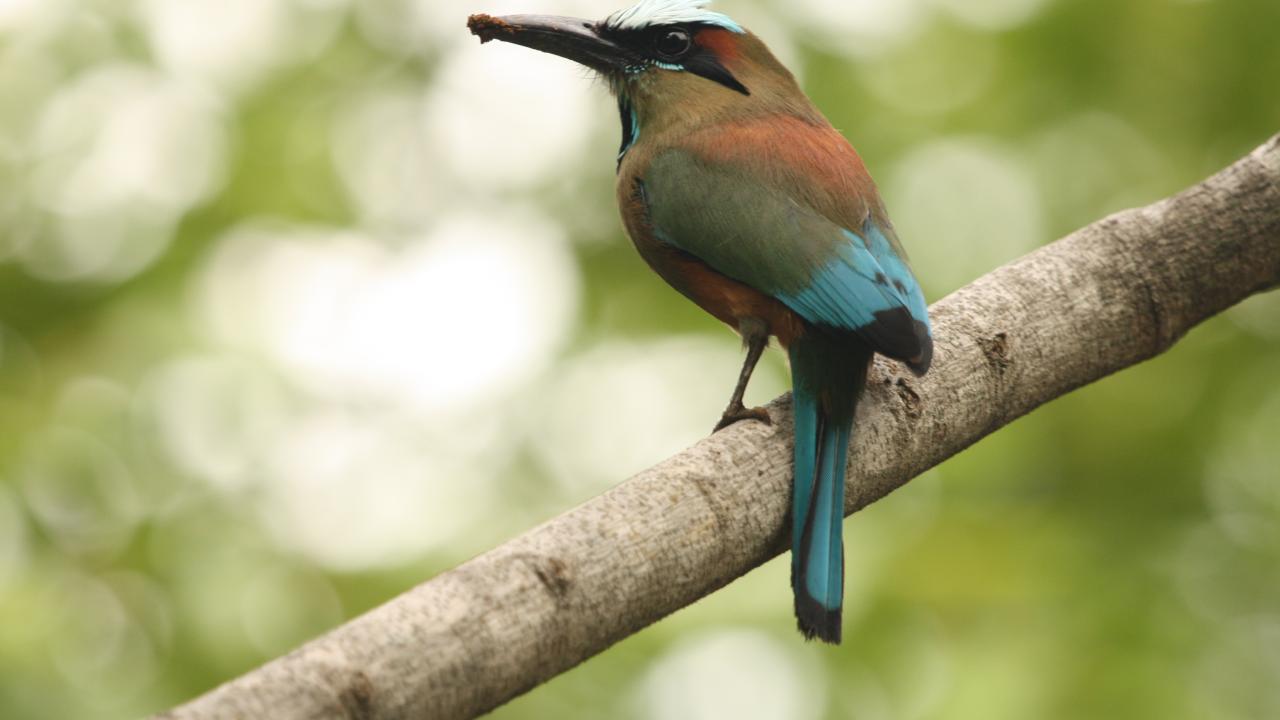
[260,410,503,570]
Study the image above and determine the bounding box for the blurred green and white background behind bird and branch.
[0,0,1280,720]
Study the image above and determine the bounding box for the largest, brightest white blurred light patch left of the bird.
[200,213,579,414]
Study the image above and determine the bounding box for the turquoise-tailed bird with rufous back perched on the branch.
[467,0,933,644]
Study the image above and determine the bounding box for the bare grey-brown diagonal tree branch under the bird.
[161,136,1280,719]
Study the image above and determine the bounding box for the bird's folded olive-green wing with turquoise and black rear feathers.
[644,151,933,373]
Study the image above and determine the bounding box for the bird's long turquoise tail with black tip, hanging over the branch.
[790,334,870,643]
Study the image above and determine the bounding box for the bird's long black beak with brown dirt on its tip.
[467,14,641,73]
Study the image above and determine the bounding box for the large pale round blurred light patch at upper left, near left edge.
[25,63,227,281]
